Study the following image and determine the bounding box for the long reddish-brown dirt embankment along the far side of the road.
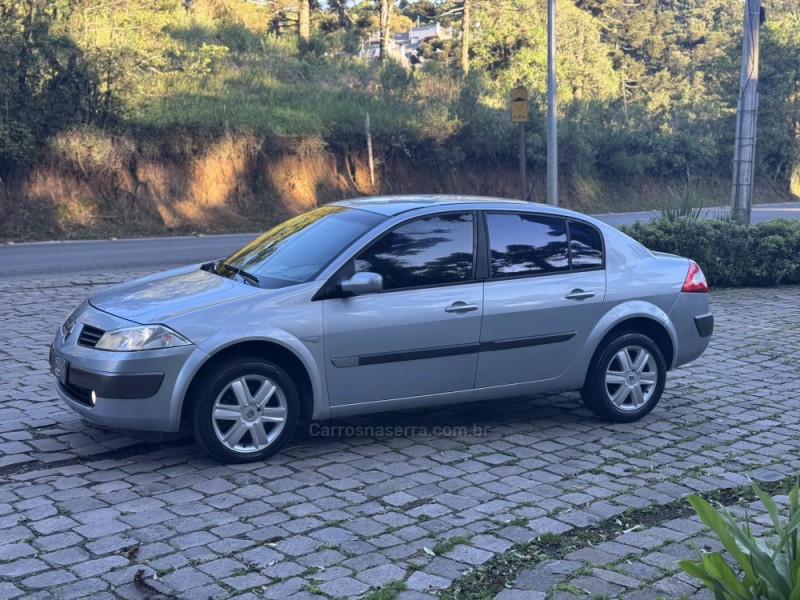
[0,131,789,242]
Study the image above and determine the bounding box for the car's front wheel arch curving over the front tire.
[181,340,314,423]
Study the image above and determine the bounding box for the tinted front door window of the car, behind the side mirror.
[355,213,475,290]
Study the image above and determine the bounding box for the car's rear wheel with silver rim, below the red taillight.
[581,333,667,423]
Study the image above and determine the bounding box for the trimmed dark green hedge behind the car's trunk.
[621,217,800,287]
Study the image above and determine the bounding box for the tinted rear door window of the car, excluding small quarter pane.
[486,213,569,277]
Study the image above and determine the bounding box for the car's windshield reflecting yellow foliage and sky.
[216,206,386,289]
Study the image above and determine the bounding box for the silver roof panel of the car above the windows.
[332,194,584,217]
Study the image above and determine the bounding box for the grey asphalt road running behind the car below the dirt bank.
[0,202,800,279]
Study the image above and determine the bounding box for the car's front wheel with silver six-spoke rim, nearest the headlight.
[193,357,300,463]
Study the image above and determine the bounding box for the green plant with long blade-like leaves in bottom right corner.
[679,484,800,600]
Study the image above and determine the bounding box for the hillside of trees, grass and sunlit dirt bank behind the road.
[0,0,800,236]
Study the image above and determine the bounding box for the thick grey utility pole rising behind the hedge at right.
[731,0,761,225]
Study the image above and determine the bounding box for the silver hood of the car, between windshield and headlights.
[89,268,268,324]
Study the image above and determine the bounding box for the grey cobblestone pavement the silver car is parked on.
[0,277,800,600]
